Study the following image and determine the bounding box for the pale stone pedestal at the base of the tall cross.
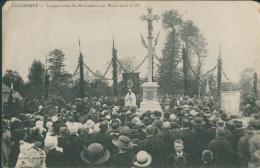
[139,82,162,114]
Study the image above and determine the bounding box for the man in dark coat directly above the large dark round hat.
[93,121,114,152]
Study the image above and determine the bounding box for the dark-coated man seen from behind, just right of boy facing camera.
[180,119,200,166]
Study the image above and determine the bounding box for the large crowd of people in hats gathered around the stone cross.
[2,96,260,168]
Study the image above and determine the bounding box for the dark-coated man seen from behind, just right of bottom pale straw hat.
[140,125,166,167]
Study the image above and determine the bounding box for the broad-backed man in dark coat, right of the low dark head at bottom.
[208,128,233,167]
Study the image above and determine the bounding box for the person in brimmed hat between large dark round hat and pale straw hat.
[109,136,134,167]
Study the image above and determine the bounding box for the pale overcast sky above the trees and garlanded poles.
[3,1,260,82]
